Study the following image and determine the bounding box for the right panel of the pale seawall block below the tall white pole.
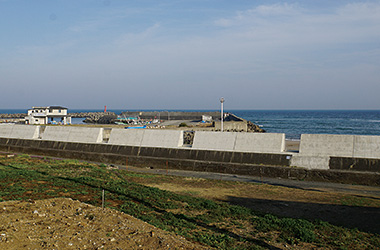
[234,133,285,153]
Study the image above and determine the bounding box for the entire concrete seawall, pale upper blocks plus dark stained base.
[0,125,380,185]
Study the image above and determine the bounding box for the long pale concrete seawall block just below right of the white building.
[41,126,103,143]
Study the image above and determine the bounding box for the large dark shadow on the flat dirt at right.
[228,196,380,234]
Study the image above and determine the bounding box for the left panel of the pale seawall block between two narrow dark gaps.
[108,129,145,147]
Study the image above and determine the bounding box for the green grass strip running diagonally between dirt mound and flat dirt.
[0,155,380,249]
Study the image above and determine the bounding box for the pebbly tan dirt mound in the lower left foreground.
[0,198,208,250]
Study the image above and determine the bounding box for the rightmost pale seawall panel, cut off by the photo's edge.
[354,135,380,158]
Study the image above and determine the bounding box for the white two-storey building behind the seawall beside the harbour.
[25,106,71,125]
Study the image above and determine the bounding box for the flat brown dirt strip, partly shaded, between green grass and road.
[120,168,380,234]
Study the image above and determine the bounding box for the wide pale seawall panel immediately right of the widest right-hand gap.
[299,134,354,157]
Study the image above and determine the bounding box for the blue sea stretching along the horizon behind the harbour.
[0,109,380,140]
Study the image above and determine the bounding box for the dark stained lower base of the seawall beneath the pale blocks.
[0,138,380,186]
